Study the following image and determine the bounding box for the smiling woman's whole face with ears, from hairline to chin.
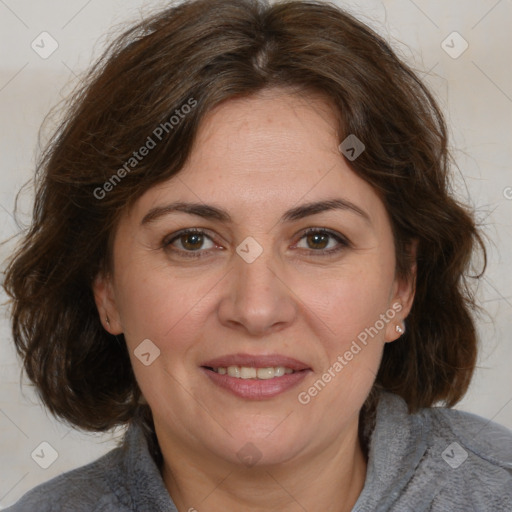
[95,90,412,464]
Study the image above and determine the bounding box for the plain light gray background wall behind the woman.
[0,0,512,509]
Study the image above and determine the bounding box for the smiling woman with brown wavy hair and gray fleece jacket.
[5,0,512,512]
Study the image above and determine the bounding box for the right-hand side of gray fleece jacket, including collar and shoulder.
[364,392,512,512]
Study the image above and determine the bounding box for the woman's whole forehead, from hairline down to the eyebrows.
[127,90,382,227]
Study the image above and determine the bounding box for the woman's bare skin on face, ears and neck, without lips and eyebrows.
[94,90,414,512]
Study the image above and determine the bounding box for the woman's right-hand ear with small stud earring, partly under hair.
[386,239,418,342]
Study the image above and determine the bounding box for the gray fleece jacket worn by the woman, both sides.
[6,393,512,512]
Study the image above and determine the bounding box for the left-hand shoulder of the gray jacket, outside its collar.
[5,448,129,512]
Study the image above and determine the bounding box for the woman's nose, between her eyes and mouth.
[218,243,299,336]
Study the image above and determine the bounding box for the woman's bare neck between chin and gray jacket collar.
[157,423,366,512]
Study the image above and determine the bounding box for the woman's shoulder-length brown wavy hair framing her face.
[4,0,485,431]
